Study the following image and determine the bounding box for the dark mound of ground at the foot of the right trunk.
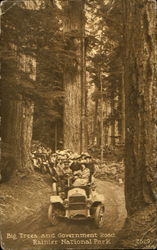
[116,205,157,249]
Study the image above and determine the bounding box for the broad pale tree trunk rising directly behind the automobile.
[64,0,87,153]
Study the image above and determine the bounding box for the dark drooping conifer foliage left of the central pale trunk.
[1,0,65,146]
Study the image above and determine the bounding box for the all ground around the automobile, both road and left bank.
[0,173,126,250]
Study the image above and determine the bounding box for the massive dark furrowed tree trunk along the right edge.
[123,0,156,214]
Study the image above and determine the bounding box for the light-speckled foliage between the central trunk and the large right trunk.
[87,0,123,130]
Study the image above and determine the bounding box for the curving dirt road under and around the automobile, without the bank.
[2,180,126,250]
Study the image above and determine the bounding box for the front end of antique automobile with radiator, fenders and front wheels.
[48,174,105,228]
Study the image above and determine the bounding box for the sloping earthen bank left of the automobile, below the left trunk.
[0,172,51,227]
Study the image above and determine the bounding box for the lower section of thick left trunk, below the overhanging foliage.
[2,94,34,170]
